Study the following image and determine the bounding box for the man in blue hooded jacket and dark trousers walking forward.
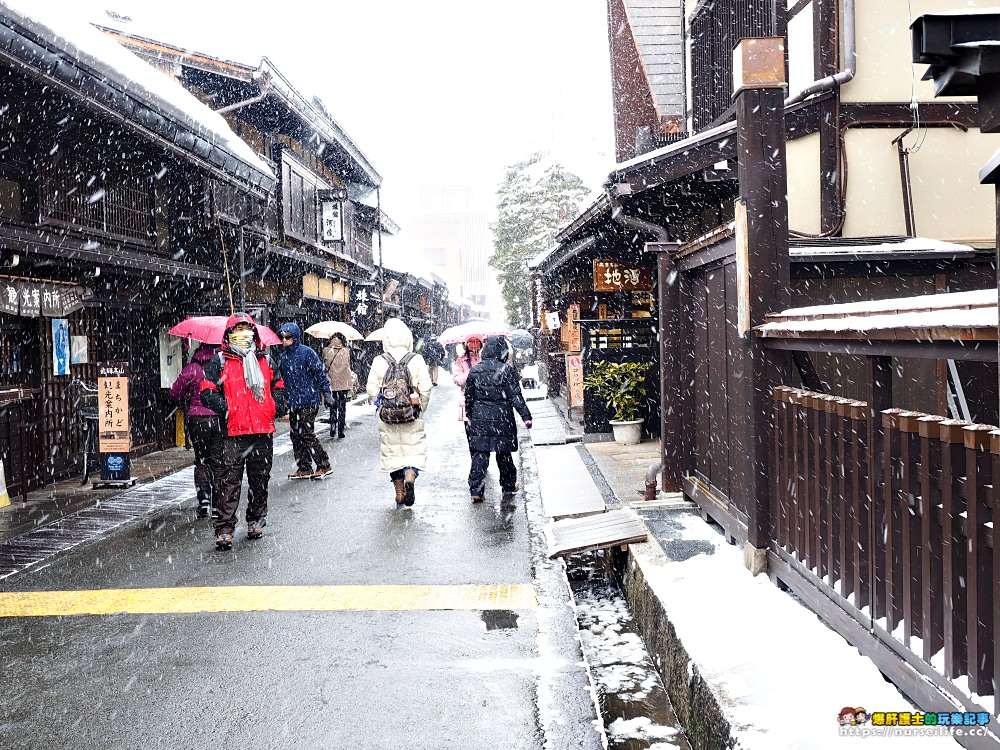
[278,323,333,479]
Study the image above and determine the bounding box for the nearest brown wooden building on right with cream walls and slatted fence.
[555,0,1000,747]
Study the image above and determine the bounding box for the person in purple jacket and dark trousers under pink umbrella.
[170,344,223,518]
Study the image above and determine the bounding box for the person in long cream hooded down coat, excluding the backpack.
[366,318,432,505]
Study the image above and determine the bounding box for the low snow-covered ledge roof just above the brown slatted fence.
[756,288,997,340]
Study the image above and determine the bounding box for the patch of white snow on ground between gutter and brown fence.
[636,516,959,750]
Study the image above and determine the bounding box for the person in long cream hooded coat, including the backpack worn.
[366,318,432,506]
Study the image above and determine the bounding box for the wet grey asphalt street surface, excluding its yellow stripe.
[0,383,601,750]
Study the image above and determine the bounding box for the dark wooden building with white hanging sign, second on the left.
[95,27,399,340]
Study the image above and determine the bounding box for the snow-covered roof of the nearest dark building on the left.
[0,0,275,191]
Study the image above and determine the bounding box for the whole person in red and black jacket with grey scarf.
[201,313,288,551]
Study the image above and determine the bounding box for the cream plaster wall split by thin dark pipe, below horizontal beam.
[844,128,1000,243]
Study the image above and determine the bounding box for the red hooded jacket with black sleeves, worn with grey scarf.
[201,313,288,437]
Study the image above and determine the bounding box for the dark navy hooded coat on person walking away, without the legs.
[465,336,531,452]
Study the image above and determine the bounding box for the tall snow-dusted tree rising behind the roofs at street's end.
[490,153,589,327]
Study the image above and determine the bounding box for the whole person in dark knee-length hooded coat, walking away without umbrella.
[465,336,531,503]
